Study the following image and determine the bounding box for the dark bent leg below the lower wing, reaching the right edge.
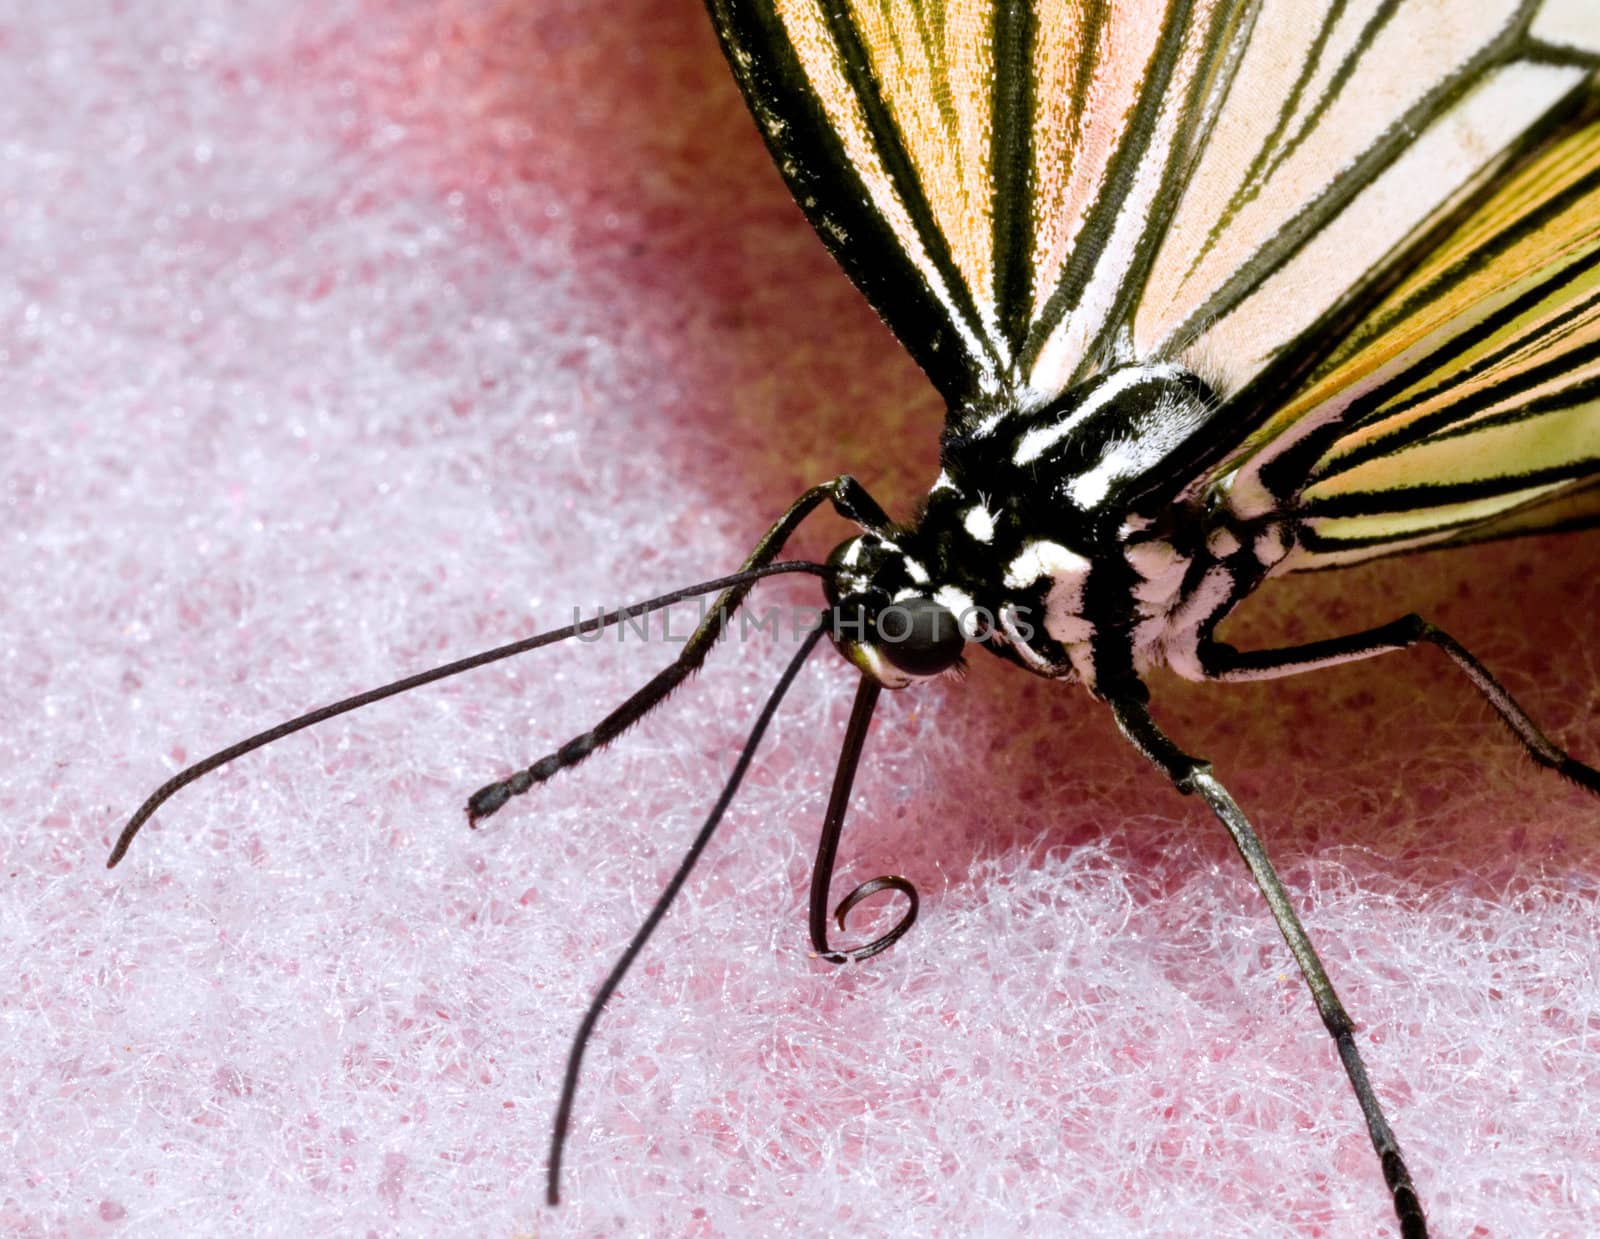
[1197,615,1600,796]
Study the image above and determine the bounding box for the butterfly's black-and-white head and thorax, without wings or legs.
[832,363,1293,695]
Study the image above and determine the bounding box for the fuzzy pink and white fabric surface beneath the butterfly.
[9,0,1600,1236]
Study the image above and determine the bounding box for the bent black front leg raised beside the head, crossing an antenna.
[467,474,890,823]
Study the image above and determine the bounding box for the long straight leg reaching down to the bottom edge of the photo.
[1110,693,1427,1239]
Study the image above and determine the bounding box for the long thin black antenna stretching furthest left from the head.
[106,560,832,869]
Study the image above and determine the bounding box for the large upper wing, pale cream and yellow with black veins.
[709,0,1600,419]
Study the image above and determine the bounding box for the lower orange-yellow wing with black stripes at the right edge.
[1226,113,1600,571]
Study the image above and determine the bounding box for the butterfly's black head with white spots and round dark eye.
[829,533,981,688]
